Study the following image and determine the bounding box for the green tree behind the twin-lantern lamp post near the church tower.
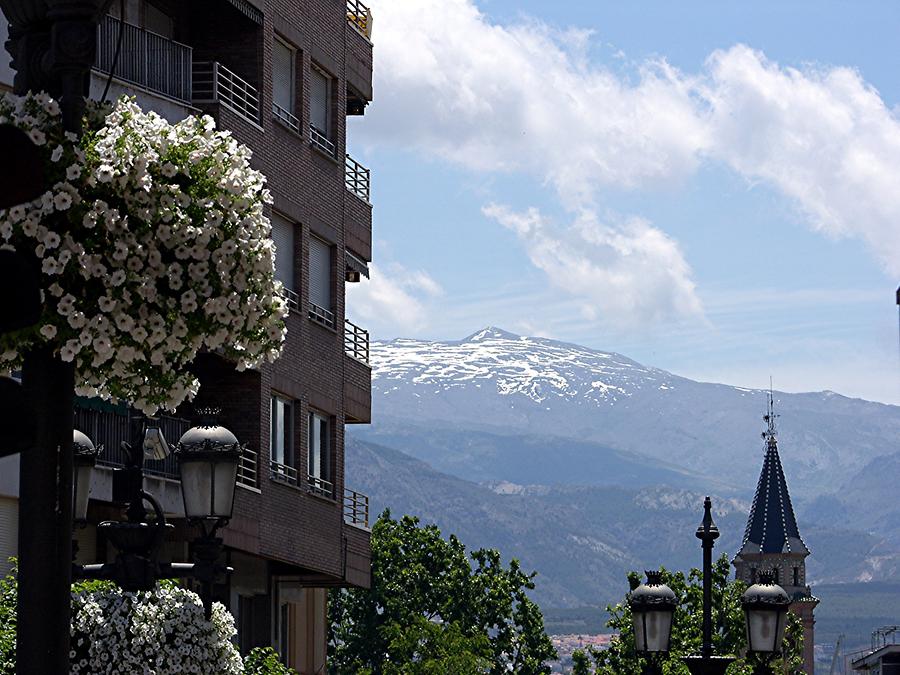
[579,555,803,675]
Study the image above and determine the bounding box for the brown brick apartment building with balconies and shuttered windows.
[0,0,372,673]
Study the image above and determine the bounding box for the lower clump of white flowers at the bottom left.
[69,585,244,675]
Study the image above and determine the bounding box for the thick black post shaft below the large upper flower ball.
[16,347,74,675]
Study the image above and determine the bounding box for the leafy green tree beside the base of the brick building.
[329,511,556,675]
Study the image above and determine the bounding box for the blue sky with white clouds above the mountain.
[348,0,900,403]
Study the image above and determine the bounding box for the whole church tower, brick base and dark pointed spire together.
[733,392,819,675]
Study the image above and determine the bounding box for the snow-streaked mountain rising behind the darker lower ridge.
[362,327,900,499]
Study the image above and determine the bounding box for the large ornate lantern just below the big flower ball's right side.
[175,408,241,524]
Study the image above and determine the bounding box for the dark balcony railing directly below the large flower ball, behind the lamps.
[75,405,191,480]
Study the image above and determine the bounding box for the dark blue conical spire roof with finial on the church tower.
[738,394,809,555]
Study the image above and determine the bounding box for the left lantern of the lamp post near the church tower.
[628,571,678,675]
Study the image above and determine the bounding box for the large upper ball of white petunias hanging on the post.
[0,94,287,414]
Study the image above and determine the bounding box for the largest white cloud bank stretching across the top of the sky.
[363,0,900,280]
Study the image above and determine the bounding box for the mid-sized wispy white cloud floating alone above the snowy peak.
[483,204,703,326]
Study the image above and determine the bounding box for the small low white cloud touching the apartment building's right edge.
[347,263,443,337]
